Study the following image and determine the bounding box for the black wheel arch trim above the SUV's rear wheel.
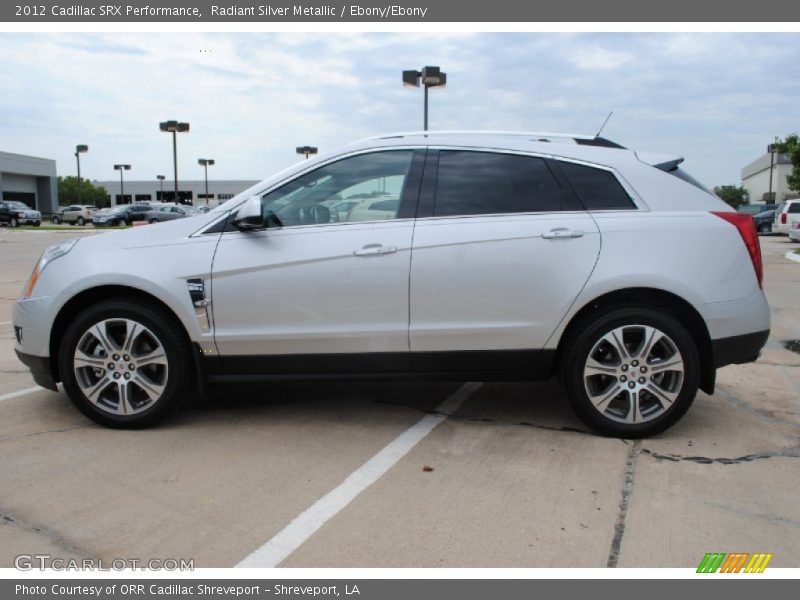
[554,287,716,394]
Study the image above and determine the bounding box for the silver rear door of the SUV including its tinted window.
[409,149,600,371]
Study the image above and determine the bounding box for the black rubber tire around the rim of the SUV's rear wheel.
[561,306,700,438]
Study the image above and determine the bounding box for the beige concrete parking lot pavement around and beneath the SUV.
[0,230,800,567]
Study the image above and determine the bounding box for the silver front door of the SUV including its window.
[212,150,424,374]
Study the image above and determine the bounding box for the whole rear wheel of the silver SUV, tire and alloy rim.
[563,307,700,438]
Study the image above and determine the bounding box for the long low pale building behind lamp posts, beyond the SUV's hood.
[92,179,258,206]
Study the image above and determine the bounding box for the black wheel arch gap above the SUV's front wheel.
[49,285,191,381]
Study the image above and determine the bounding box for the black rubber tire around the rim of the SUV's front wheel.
[58,298,194,429]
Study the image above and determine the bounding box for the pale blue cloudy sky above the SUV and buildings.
[0,33,800,186]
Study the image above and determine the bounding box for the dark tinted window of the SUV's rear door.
[433,150,564,217]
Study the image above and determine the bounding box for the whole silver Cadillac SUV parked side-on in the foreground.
[13,132,770,437]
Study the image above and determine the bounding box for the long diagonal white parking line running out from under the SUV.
[236,383,481,567]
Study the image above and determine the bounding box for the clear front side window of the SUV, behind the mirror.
[261,150,413,227]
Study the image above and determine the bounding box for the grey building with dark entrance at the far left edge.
[0,152,58,213]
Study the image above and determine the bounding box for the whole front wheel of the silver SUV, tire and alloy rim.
[59,299,193,429]
